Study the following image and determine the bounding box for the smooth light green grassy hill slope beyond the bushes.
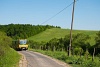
[28,28,98,45]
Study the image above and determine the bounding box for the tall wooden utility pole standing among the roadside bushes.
[68,0,76,56]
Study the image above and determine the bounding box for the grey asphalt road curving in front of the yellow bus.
[20,51,69,67]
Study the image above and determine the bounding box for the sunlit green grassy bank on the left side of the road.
[0,32,20,67]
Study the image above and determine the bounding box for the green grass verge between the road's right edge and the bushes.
[31,49,100,67]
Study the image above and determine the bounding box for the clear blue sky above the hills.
[0,0,100,30]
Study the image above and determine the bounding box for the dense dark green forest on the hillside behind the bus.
[0,24,60,39]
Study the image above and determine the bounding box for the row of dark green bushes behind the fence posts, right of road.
[29,31,100,56]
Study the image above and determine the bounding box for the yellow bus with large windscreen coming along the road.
[12,39,28,50]
